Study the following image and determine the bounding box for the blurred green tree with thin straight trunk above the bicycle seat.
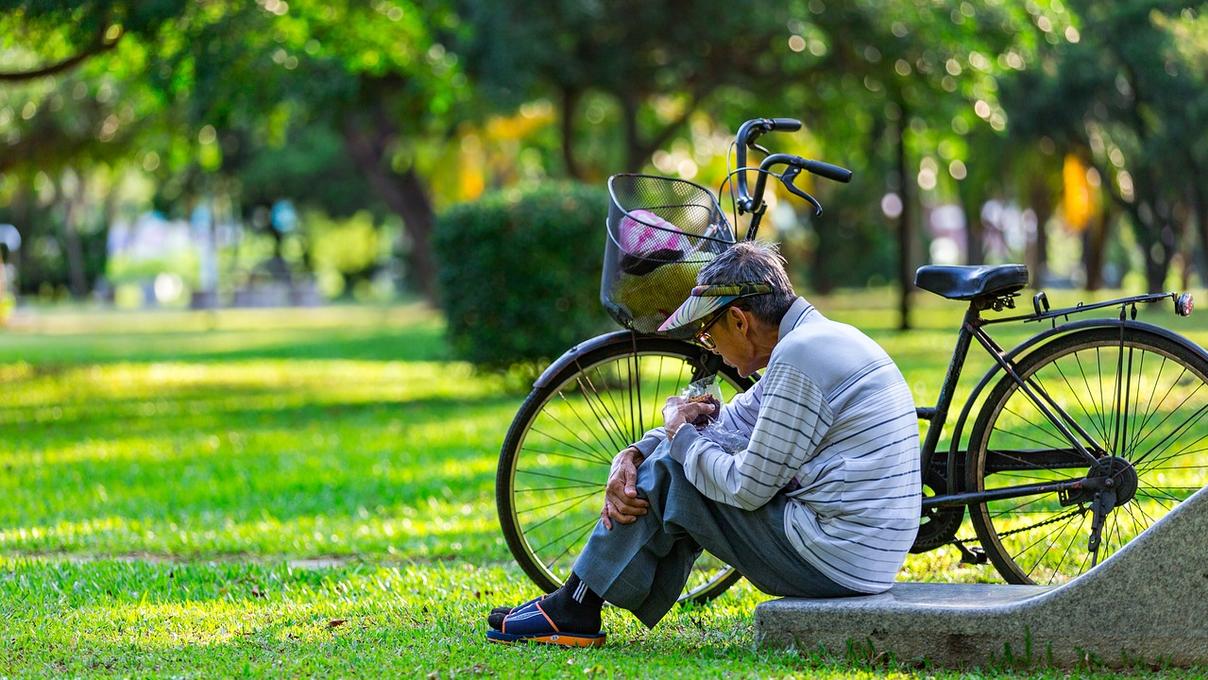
[777,1,1015,330]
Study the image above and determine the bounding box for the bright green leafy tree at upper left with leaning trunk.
[0,0,466,303]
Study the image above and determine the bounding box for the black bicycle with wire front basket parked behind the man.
[495,118,1208,601]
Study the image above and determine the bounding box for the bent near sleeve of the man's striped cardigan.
[670,364,832,510]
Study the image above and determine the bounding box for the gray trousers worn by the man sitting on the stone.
[574,443,861,628]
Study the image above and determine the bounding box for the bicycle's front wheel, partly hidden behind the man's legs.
[495,337,754,601]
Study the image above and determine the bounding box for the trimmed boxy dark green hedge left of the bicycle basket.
[434,184,608,368]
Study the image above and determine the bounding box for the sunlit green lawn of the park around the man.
[0,293,1208,676]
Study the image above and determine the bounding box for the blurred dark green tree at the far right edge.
[1004,0,1208,290]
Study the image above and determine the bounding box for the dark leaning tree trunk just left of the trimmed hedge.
[343,120,437,304]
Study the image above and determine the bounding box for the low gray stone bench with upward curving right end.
[755,488,1208,667]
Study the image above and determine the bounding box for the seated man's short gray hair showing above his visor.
[696,240,797,326]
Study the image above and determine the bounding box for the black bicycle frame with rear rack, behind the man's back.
[916,292,1203,508]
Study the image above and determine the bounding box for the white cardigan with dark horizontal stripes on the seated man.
[637,298,922,593]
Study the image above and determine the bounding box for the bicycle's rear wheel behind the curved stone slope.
[966,326,1208,585]
